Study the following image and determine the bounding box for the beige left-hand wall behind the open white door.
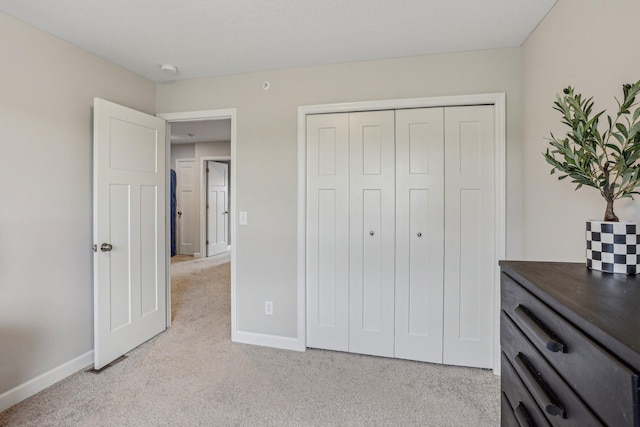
[0,13,155,395]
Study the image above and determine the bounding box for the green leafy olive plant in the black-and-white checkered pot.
[543,80,640,222]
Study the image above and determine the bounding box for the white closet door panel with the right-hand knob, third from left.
[395,108,444,363]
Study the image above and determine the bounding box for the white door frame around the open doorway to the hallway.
[157,108,238,341]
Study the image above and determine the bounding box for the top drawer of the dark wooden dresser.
[501,273,638,427]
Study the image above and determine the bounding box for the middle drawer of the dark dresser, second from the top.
[500,312,604,427]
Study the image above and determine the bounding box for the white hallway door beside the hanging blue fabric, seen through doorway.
[176,159,198,255]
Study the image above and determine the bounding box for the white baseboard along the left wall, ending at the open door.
[0,350,93,412]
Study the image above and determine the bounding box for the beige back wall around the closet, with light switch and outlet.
[156,49,522,337]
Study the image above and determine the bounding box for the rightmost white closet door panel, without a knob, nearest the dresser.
[443,106,496,368]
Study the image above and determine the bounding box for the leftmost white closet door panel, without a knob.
[307,114,349,351]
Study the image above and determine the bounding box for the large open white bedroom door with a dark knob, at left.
[93,98,167,369]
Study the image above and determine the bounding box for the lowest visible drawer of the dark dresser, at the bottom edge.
[500,353,550,427]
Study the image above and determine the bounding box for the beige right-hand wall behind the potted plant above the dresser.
[522,0,640,262]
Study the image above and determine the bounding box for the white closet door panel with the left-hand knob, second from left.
[349,111,395,357]
